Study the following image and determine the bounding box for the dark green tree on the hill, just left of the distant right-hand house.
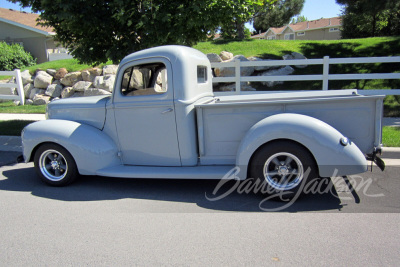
[253,0,305,32]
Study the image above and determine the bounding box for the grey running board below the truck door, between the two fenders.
[96,165,235,179]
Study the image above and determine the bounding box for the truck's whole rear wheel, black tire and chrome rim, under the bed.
[249,141,318,199]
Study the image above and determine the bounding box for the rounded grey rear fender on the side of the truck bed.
[236,113,367,179]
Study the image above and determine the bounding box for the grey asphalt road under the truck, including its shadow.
[0,159,400,266]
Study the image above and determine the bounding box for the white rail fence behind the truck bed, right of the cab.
[211,56,400,95]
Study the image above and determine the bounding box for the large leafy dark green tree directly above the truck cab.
[9,0,275,64]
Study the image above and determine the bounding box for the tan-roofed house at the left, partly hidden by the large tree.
[0,8,71,63]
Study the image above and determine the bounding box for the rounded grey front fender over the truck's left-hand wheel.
[22,120,121,175]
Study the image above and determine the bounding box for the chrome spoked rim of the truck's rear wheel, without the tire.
[263,152,304,190]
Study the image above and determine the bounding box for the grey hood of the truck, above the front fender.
[46,96,110,130]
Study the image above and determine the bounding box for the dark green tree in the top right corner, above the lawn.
[336,0,400,38]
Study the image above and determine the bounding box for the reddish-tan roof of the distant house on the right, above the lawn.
[252,17,342,36]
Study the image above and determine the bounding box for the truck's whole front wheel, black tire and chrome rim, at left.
[34,144,79,186]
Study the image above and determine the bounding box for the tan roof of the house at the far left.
[0,8,55,35]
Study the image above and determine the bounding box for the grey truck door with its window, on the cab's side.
[113,58,181,166]
